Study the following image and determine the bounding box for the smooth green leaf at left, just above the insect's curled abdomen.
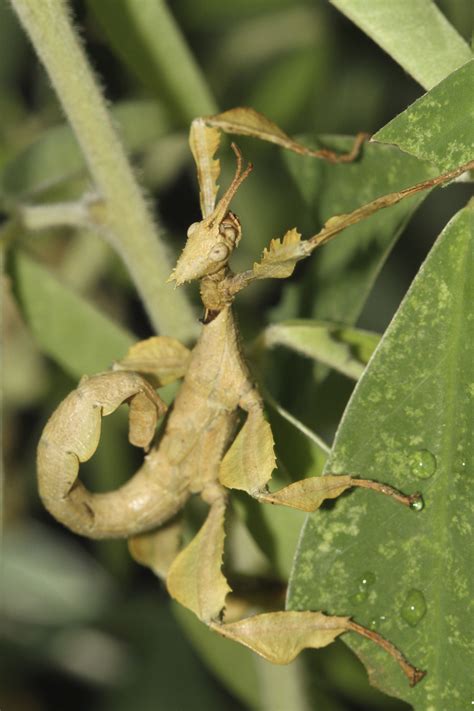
[13,251,135,378]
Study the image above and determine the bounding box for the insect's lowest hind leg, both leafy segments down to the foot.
[148,436,424,685]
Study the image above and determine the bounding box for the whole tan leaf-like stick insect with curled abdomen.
[38,109,474,685]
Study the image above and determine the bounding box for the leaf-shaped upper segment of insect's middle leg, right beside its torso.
[219,408,275,494]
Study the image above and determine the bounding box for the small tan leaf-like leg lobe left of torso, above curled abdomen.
[114,336,191,388]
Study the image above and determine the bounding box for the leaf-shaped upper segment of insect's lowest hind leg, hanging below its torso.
[166,499,231,622]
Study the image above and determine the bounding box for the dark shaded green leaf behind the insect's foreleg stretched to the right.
[285,136,437,324]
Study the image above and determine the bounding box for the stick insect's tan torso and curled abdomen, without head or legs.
[37,307,252,538]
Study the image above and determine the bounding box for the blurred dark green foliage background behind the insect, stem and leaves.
[0,0,471,711]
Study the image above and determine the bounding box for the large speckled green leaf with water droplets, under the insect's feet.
[288,202,474,710]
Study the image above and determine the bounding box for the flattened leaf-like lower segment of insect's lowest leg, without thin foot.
[211,612,349,664]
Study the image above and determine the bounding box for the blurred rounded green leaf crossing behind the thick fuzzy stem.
[0,100,169,196]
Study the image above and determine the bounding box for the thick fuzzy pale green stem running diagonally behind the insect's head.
[12,0,197,341]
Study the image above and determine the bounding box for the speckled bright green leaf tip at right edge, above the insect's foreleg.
[373,60,474,172]
